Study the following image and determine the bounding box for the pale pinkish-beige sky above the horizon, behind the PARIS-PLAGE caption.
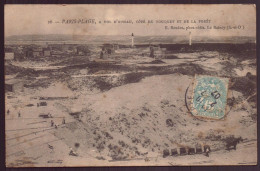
[4,4,256,37]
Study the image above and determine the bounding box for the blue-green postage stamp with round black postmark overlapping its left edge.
[185,75,229,120]
